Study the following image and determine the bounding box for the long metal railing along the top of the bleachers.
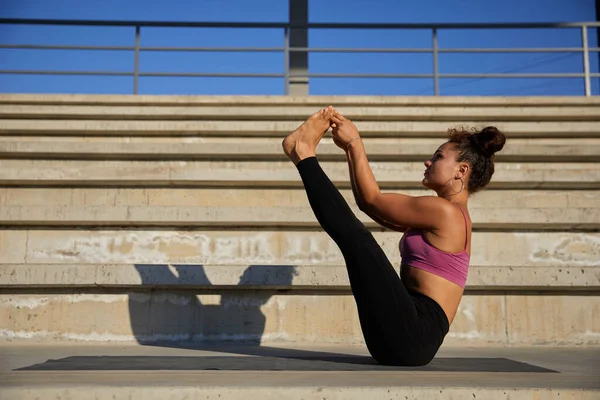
[0,18,600,96]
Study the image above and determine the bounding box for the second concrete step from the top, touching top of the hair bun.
[0,118,600,139]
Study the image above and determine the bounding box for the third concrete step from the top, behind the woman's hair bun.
[0,136,600,162]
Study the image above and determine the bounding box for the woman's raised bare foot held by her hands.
[281,106,333,165]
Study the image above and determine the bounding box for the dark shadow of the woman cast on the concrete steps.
[129,264,296,346]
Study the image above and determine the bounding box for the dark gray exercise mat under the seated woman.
[17,356,557,373]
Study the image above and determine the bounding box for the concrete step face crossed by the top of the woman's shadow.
[0,264,600,292]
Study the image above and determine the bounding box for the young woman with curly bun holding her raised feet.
[282,106,506,366]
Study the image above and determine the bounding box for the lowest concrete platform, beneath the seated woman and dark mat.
[0,345,600,400]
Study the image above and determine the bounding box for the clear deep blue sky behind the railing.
[0,0,600,95]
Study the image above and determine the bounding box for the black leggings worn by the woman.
[297,157,449,366]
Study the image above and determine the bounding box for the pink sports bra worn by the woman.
[399,207,470,288]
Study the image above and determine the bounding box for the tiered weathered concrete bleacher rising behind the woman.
[0,95,600,398]
